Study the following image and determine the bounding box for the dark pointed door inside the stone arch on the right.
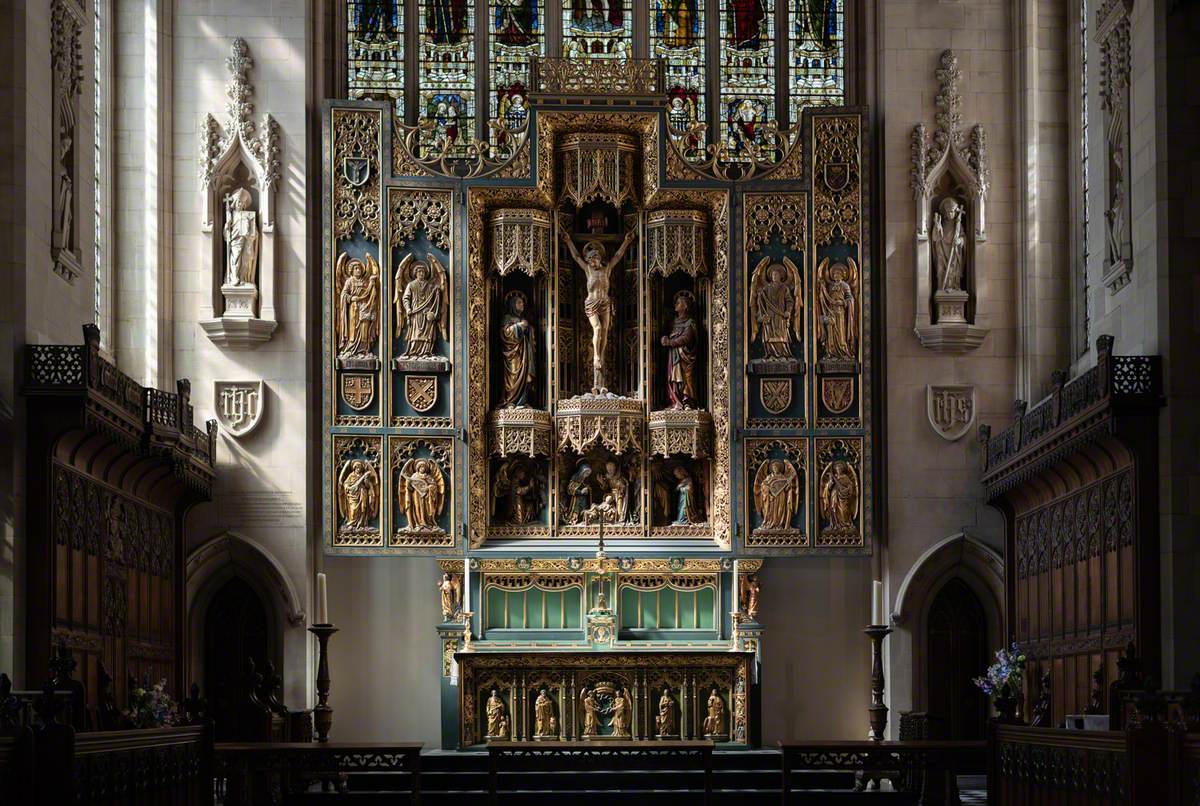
[925,578,988,739]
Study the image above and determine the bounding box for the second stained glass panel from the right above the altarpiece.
[719,0,775,158]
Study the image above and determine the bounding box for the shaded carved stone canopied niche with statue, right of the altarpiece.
[912,50,988,354]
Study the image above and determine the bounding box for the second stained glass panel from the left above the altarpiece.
[418,0,475,156]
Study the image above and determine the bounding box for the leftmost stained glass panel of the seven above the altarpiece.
[346,0,404,118]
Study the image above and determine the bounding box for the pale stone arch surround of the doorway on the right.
[889,533,1006,727]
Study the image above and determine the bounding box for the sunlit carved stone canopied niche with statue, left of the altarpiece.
[199,37,280,348]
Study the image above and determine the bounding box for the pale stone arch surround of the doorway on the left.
[186,531,305,692]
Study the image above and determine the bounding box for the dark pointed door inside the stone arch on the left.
[204,577,270,741]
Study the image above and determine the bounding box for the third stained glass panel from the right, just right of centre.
[650,0,706,141]
